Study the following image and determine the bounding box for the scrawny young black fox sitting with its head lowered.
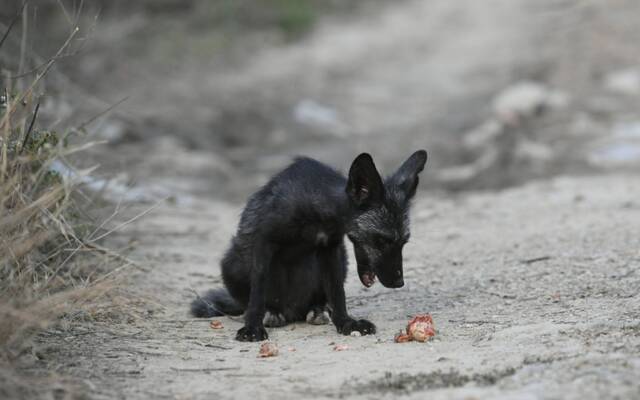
[191,150,427,341]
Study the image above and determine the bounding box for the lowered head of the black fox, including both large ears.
[346,150,427,288]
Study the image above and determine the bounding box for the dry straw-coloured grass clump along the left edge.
[0,2,136,397]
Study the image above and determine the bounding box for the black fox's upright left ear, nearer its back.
[347,153,384,208]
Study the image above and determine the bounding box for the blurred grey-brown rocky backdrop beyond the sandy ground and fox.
[0,0,640,200]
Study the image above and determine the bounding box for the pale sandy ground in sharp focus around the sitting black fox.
[36,175,640,399]
